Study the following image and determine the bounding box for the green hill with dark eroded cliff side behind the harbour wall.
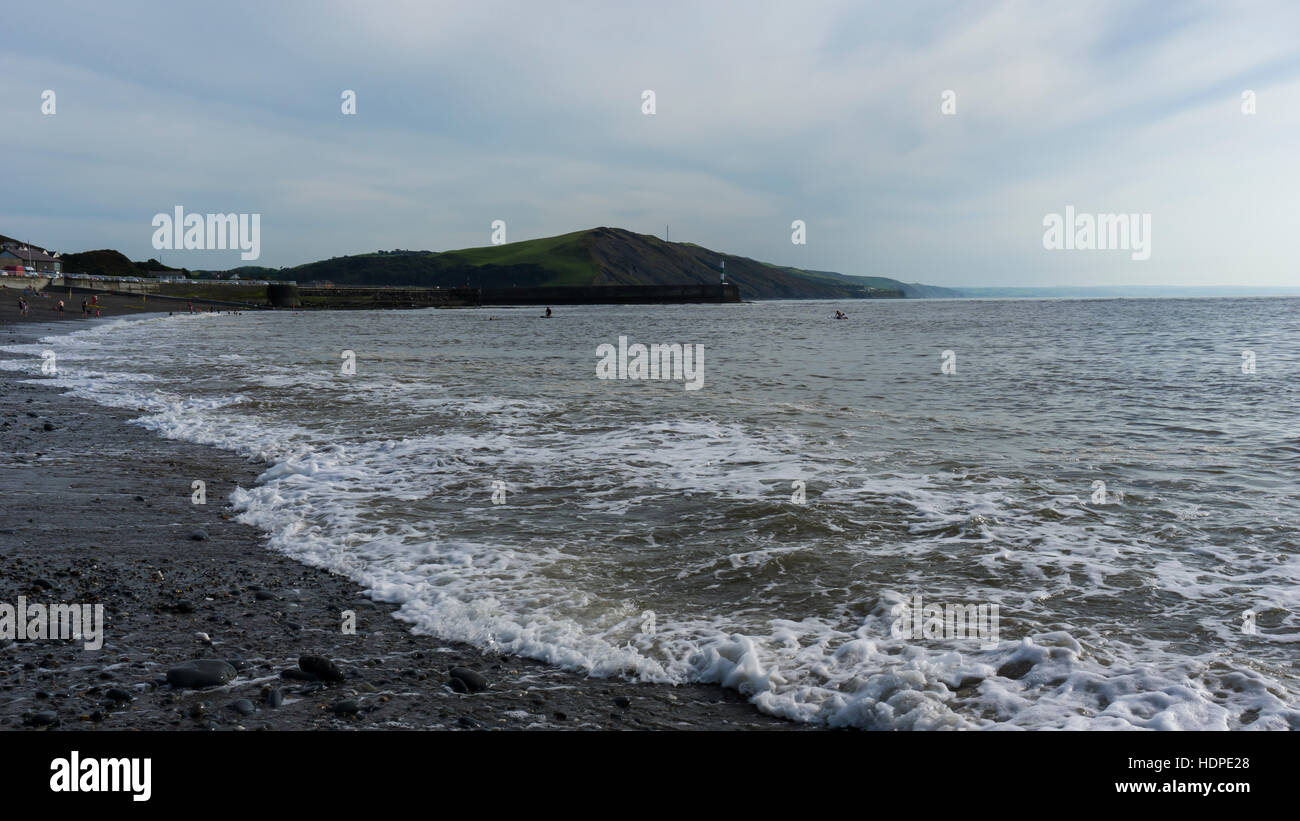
[258,227,957,299]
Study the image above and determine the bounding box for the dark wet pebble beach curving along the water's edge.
[0,307,800,730]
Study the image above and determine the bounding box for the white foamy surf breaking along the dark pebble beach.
[10,310,1300,730]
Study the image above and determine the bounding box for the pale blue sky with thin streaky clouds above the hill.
[0,0,1300,287]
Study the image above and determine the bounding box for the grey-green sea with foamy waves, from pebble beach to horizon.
[0,299,1300,730]
